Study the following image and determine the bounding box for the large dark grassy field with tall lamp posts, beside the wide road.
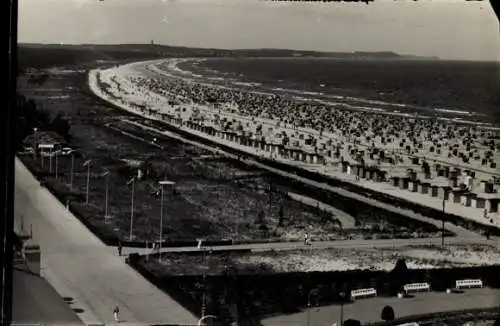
[17,113,444,241]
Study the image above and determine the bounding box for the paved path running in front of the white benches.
[262,288,500,326]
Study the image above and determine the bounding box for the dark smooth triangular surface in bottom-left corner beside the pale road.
[12,269,83,326]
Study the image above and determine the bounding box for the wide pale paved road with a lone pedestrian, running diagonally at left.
[15,159,197,324]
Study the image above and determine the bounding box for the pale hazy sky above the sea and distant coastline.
[19,0,500,61]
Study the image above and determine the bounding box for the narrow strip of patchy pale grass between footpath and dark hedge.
[137,245,500,276]
